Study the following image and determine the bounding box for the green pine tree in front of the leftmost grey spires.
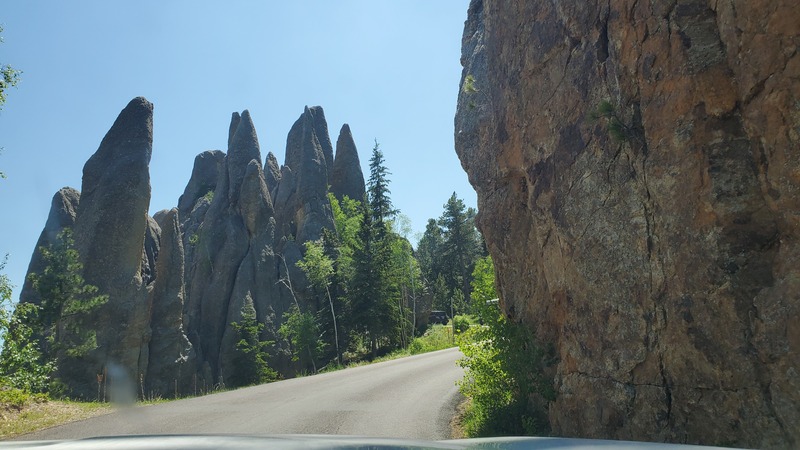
[29,228,108,360]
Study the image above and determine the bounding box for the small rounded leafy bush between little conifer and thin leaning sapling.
[278,305,325,372]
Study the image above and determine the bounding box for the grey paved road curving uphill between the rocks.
[18,349,463,440]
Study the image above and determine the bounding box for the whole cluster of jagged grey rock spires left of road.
[21,98,364,398]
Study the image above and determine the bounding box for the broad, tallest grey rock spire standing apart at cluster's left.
[69,97,153,396]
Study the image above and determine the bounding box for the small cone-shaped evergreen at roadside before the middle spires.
[230,295,278,386]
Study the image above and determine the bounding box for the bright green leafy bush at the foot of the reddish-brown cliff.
[459,256,555,437]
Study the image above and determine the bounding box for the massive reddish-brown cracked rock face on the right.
[455,0,800,448]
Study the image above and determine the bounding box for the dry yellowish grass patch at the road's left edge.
[0,394,112,439]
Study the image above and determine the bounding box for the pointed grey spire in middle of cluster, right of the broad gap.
[187,111,277,382]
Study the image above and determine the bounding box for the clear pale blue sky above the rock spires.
[0,0,476,297]
